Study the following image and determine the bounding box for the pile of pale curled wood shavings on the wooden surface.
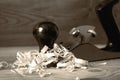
[13,44,88,77]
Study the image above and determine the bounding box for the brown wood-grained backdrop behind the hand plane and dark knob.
[0,0,120,47]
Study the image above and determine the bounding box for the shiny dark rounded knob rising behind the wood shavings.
[33,21,59,51]
